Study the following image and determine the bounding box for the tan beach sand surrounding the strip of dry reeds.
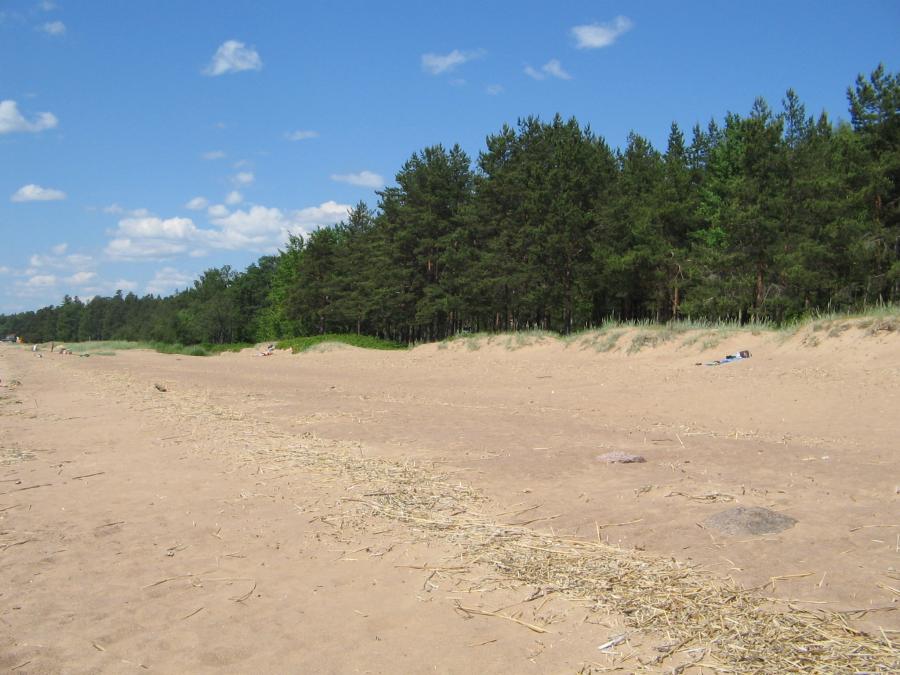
[0,329,900,673]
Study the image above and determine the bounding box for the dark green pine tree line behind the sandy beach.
[0,66,900,344]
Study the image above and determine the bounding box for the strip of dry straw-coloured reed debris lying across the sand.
[251,445,900,673]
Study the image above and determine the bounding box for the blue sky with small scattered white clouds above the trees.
[0,0,900,313]
